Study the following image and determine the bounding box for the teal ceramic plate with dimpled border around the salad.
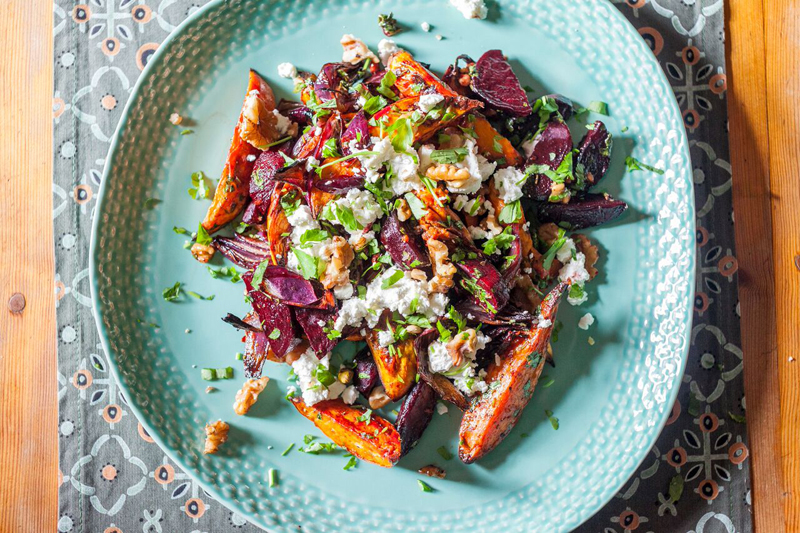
[92,0,694,531]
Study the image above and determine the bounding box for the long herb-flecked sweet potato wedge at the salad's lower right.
[458,283,568,464]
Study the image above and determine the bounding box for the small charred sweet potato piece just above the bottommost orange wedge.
[367,329,417,400]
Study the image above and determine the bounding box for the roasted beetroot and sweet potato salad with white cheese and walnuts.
[191,35,627,468]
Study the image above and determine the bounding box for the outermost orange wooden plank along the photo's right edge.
[764,0,800,531]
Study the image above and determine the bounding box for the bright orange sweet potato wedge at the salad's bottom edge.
[292,397,401,467]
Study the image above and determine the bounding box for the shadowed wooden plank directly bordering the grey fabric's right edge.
[727,0,785,532]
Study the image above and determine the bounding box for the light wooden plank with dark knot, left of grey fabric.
[0,0,58,531]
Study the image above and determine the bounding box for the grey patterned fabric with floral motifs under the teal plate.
[53,0,752,533]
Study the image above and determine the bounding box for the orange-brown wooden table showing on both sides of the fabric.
[0,0,800,533]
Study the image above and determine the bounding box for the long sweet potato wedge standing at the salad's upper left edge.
[203,70,275,233]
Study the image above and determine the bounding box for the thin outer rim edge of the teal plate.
[89,0,697,530]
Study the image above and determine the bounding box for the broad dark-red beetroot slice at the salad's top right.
[472,50,531,117]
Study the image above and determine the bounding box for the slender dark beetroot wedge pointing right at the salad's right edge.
[538,194,628,229]
